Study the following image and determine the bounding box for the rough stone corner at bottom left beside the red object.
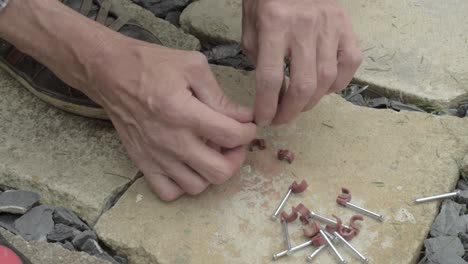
[0,228,109,264]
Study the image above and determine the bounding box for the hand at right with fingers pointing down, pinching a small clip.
[242,0,362,126]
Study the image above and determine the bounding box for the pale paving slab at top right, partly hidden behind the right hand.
[181,0,468,109]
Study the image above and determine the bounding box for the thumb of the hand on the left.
[189,63,253,123]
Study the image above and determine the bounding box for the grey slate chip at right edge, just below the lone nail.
[431,200,468,236]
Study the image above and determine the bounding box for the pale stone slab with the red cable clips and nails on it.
[96,66,468,264]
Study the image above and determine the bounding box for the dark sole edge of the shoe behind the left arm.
[0,60,109,120]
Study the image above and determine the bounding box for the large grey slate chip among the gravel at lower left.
[15,205,54,241]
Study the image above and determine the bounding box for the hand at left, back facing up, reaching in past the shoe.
[88,37,256,201]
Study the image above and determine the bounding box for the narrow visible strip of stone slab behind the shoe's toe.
[115,0,200,50]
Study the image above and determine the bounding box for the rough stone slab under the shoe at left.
[0,68,137,224]
